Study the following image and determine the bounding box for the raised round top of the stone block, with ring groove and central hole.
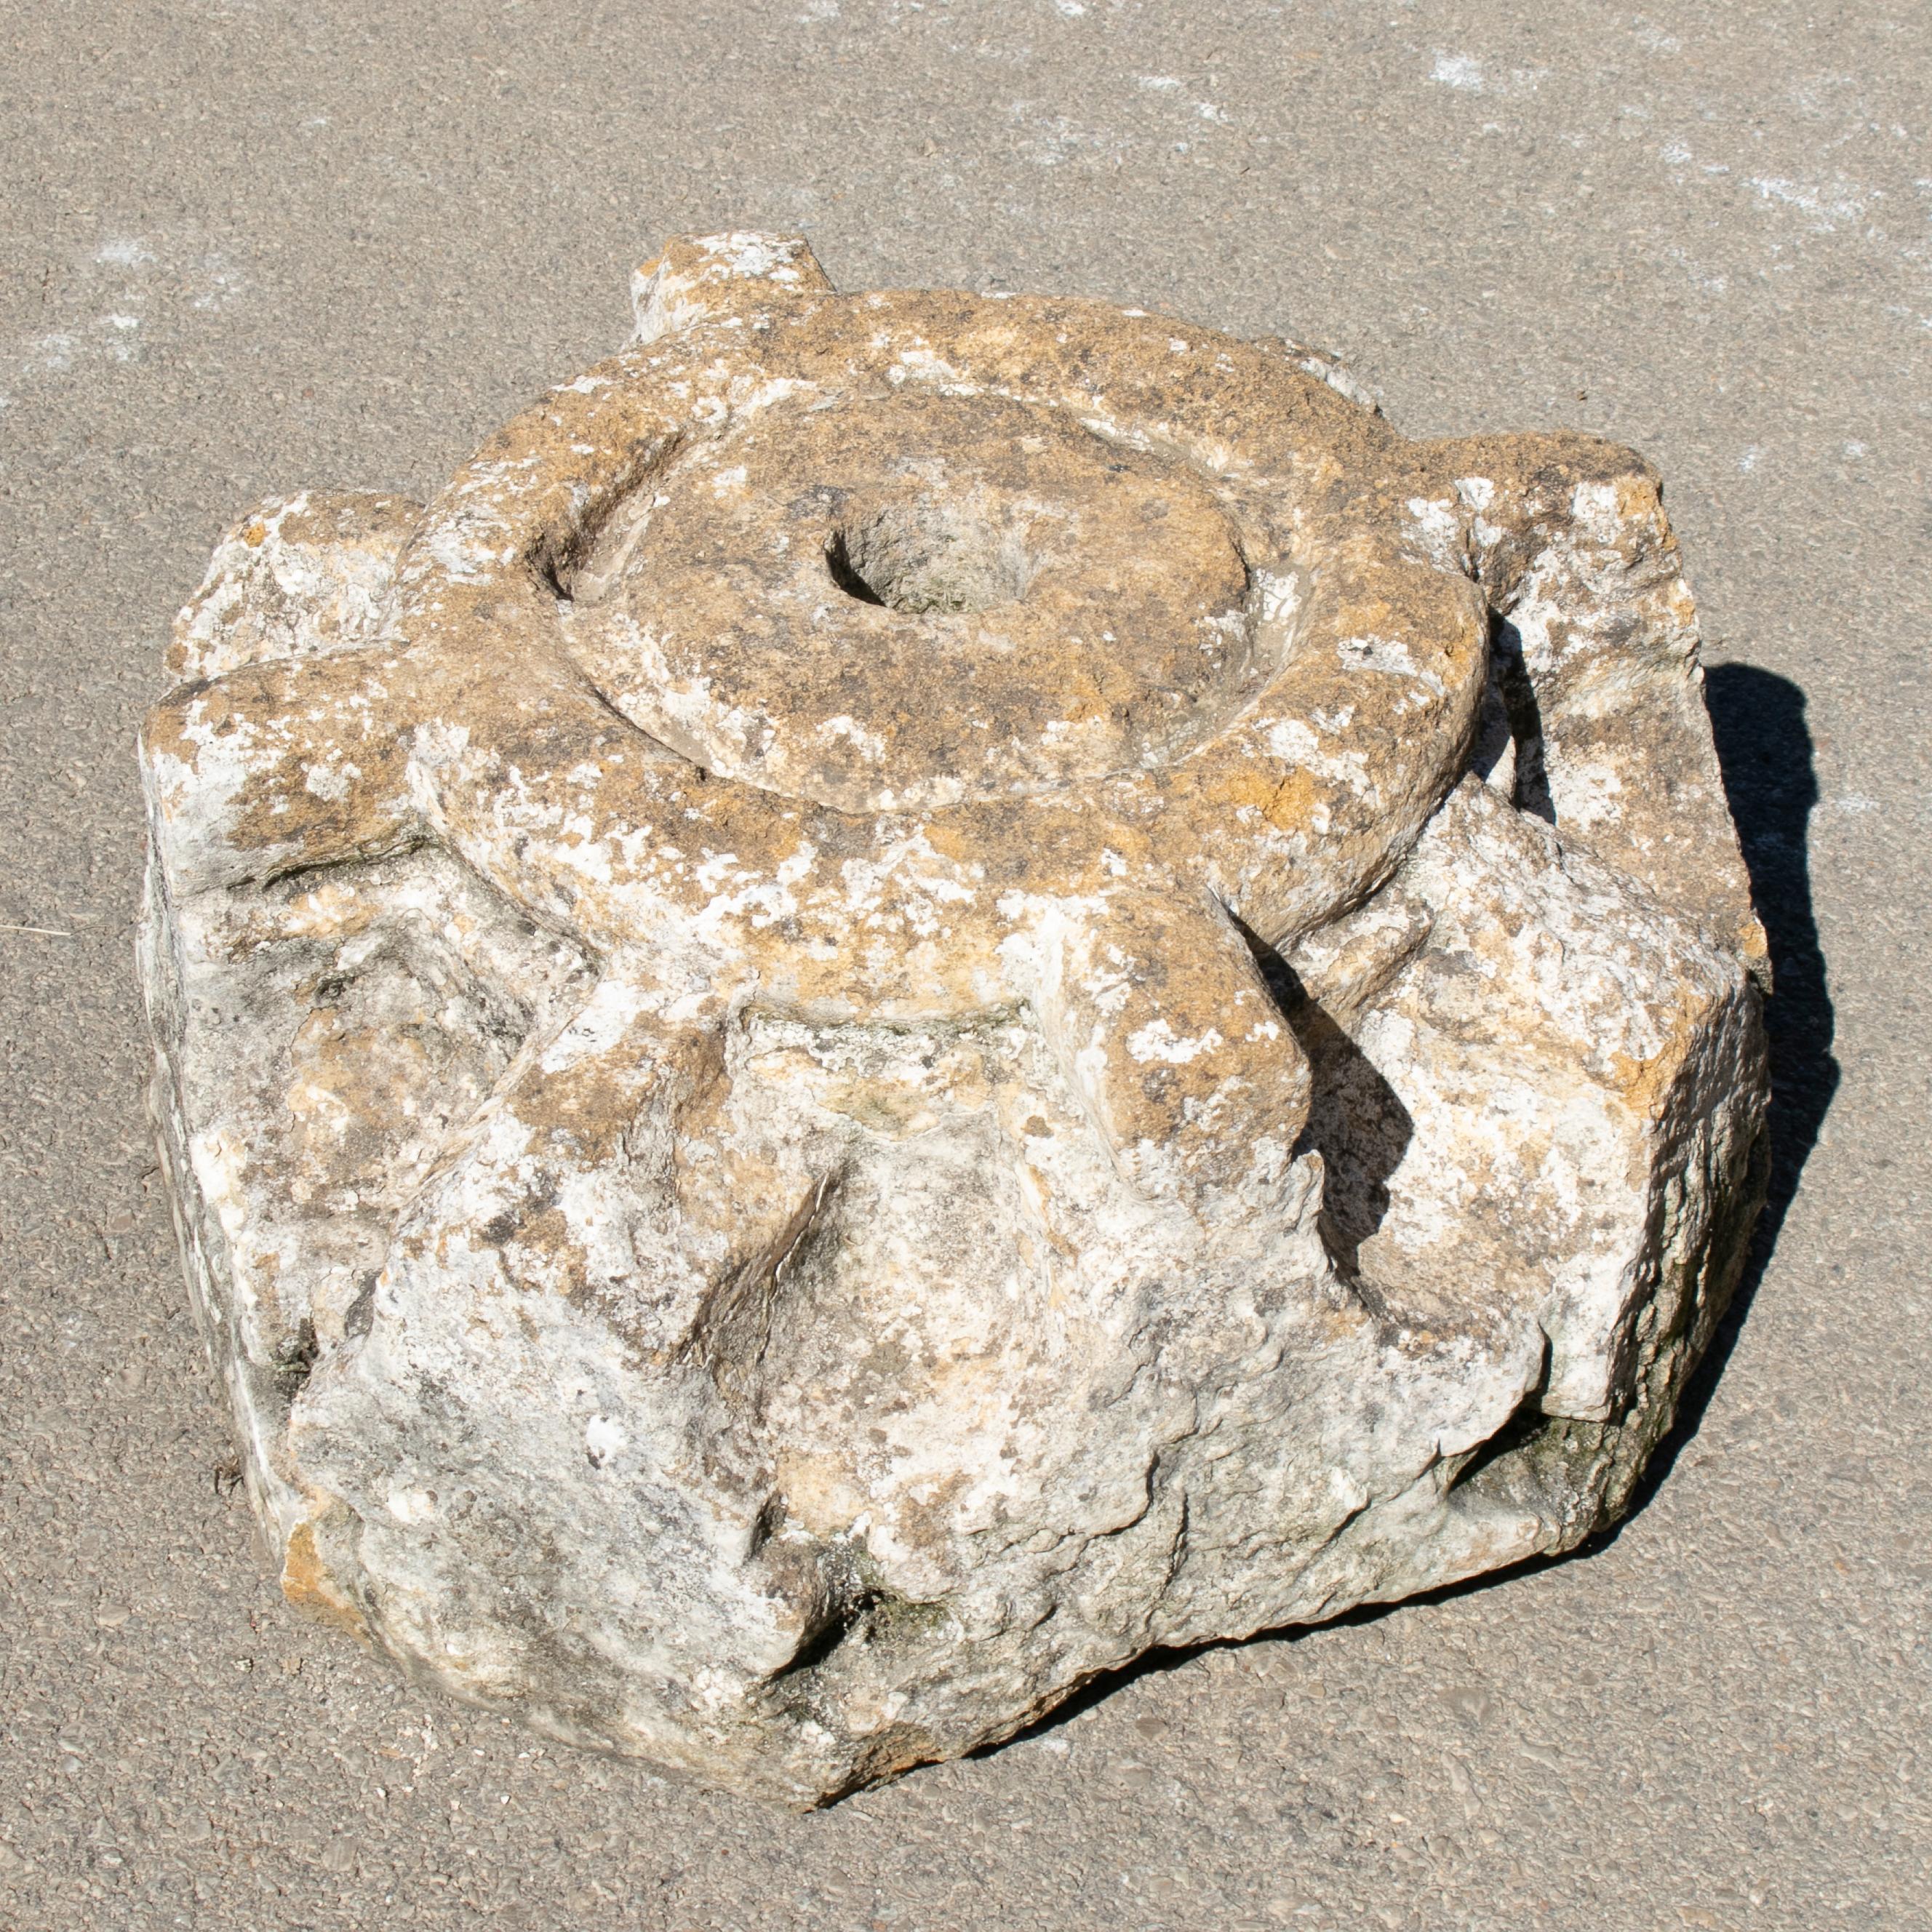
[376,238,1485,1205]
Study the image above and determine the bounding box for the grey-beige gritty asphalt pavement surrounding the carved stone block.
[0,0,1932,1932]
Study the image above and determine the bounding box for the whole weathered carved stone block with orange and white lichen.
[141,236,1766,1805]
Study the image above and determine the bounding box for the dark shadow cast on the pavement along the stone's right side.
[975,665,1840,1756]
